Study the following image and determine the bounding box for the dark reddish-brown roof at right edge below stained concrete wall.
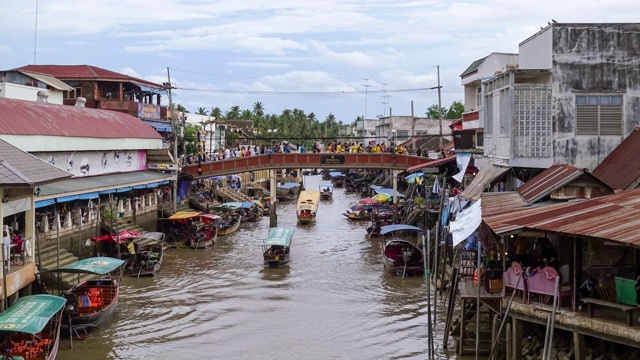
[592,128,640,190]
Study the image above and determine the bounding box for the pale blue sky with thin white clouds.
[0,0,640,124]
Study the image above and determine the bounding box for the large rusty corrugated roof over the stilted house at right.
[482,189,640,246]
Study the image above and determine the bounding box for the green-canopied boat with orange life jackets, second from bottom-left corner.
[41,257,125,338]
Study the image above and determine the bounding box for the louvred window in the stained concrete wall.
[576,95,622,136]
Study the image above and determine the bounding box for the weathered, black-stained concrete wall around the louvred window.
[552,24,640,170]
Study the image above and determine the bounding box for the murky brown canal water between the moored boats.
[58,176,455,360]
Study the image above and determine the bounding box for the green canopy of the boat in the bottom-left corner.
[0,295,67,335]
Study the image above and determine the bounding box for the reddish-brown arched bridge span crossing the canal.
[182,153,455,178]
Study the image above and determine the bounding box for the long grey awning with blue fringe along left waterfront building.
[37,171,175,202]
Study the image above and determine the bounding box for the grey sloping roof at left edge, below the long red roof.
[0,136,73,187]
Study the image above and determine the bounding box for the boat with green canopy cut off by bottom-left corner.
[0,294,67,360]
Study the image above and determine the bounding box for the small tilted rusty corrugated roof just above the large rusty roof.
[517,164,585,204]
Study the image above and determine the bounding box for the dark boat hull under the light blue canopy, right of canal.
[383,240,424,276]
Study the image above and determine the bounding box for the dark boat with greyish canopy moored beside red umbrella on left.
[128,232,164,277]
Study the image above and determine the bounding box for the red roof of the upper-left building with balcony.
[17,65,162,89]
